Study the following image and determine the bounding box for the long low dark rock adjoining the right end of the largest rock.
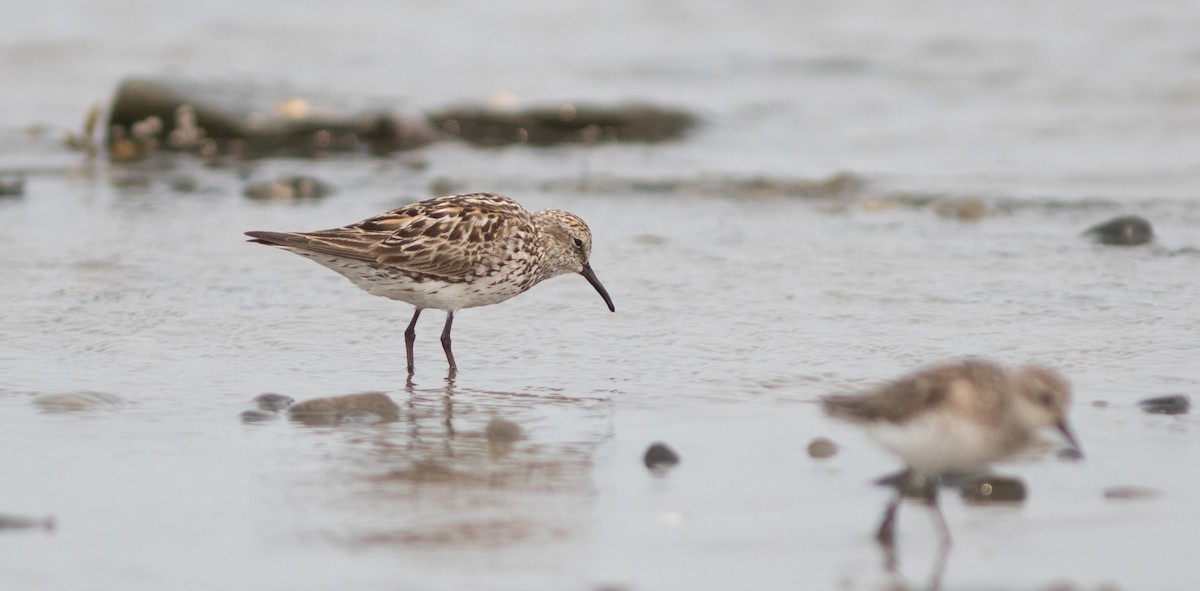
[428,103,696,147]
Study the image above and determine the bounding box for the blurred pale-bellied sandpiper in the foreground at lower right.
[822,359,1079,547]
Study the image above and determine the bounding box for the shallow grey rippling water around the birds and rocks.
[0,1,1200,590]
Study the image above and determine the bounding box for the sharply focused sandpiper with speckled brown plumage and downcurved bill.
[246,193,617,376]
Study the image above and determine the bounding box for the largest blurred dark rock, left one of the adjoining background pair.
[106,78,438,161]
